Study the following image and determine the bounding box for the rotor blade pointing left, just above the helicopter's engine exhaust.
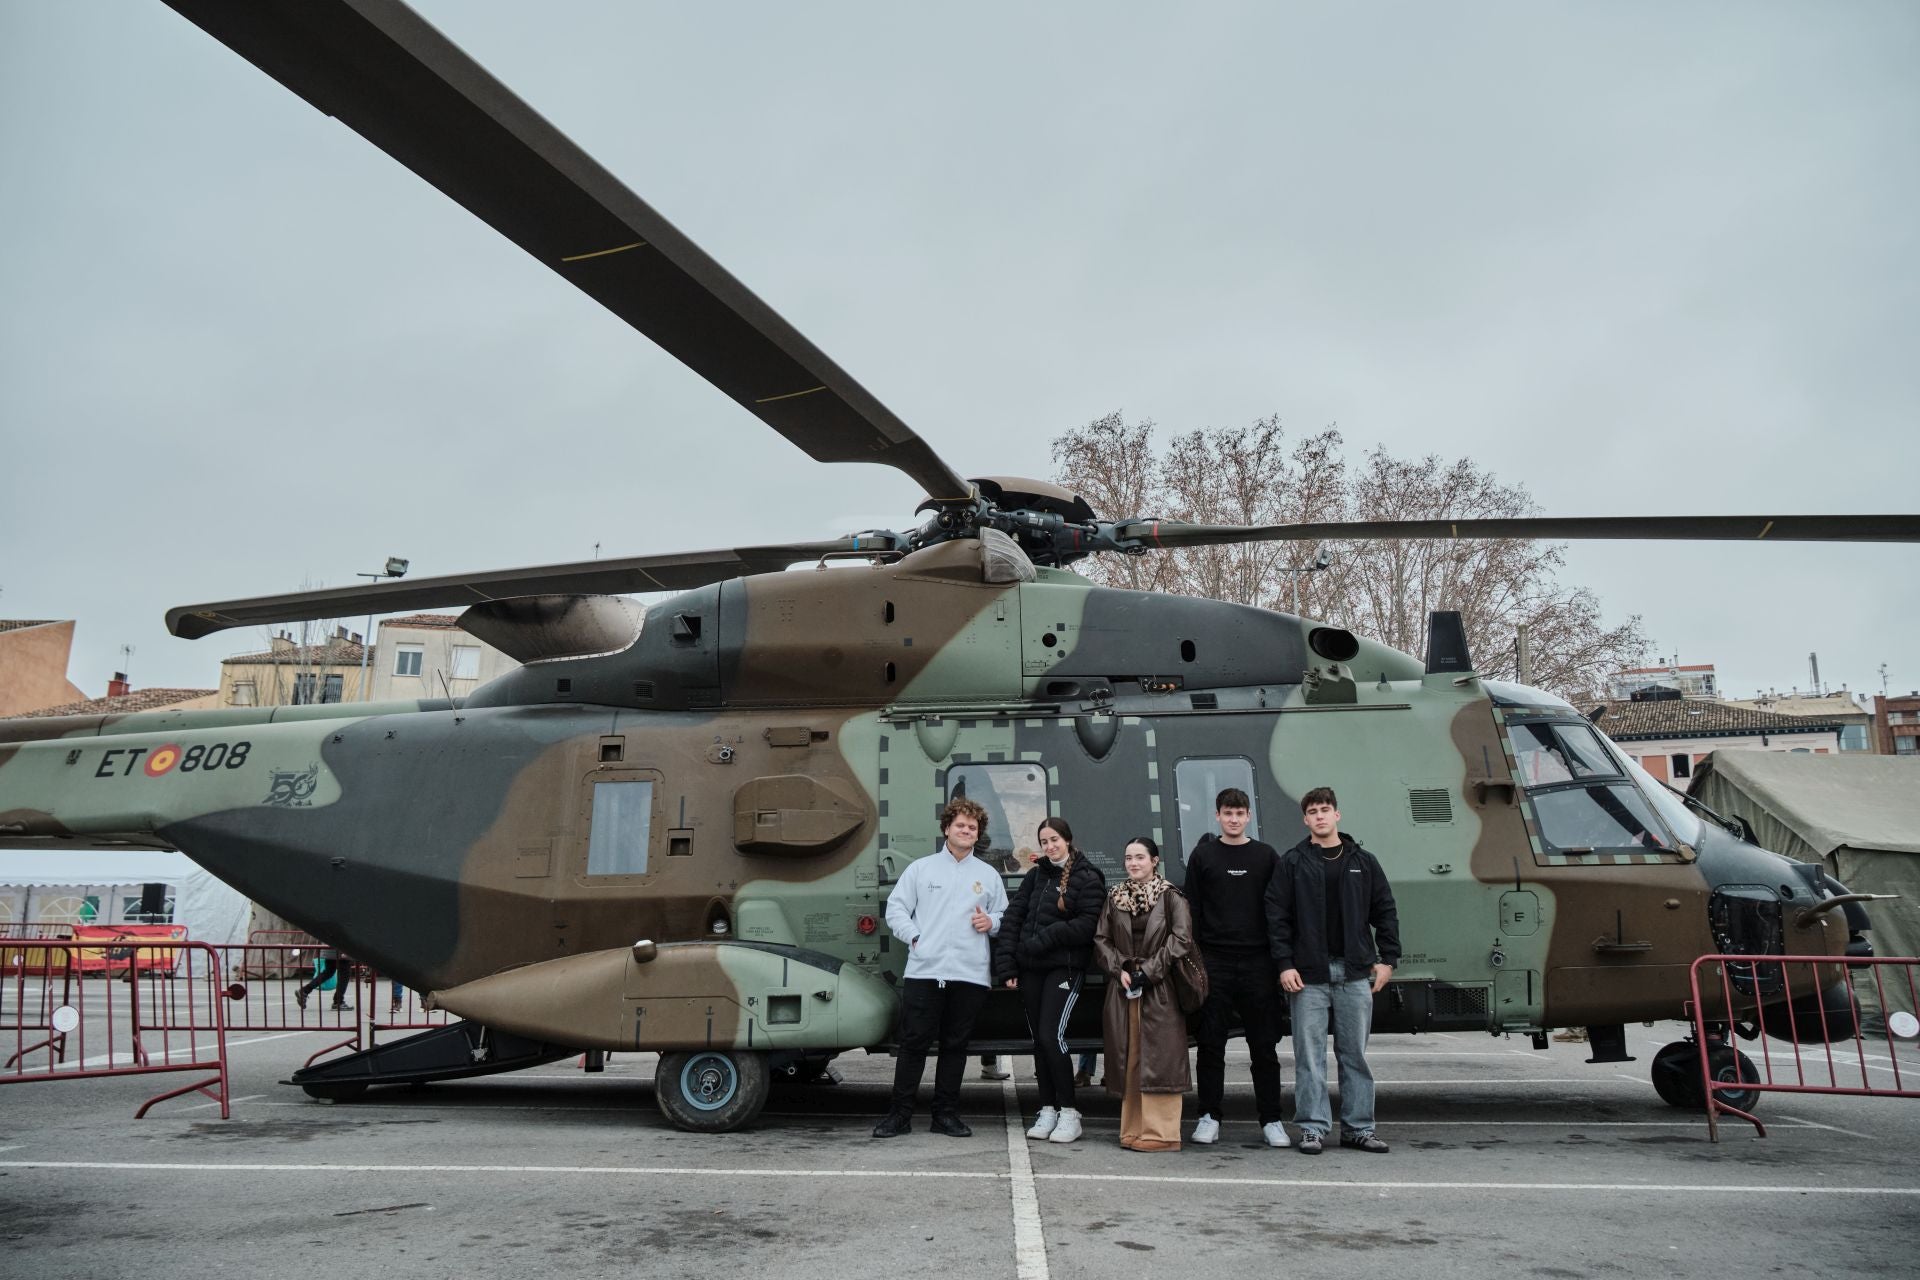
[167,537,889,639]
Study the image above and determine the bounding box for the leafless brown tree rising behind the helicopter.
[1054,413,1647,693]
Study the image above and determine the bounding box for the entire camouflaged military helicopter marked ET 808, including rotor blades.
[0,0,1920,1132]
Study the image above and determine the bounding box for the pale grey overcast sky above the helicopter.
[0,0,1920,695]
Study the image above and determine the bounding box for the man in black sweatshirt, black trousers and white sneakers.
[1185,787,1286,1148]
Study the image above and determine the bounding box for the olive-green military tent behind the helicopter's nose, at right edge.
[1688,750,1920,1011]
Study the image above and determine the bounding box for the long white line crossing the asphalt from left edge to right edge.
[0,1161,1920,1197]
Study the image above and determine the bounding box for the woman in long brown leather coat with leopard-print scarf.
[1092,835,1194,1151]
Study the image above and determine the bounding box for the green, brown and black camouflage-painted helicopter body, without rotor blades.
[0,539,1847,1050]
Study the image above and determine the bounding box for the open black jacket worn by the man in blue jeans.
[1267,831,1400,983]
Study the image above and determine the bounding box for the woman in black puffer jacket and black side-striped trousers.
[993,818,1106,1142]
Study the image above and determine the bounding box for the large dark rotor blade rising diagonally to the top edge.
[167,0,972,499]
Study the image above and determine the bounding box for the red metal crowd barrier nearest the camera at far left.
[0,940,230,1119]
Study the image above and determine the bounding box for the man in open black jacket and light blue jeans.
[1267,787,1400,1155]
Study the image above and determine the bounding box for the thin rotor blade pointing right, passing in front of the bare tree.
[1114,516,1920,549]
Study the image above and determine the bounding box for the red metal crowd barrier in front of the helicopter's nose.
[1690,956,1920,1142]
